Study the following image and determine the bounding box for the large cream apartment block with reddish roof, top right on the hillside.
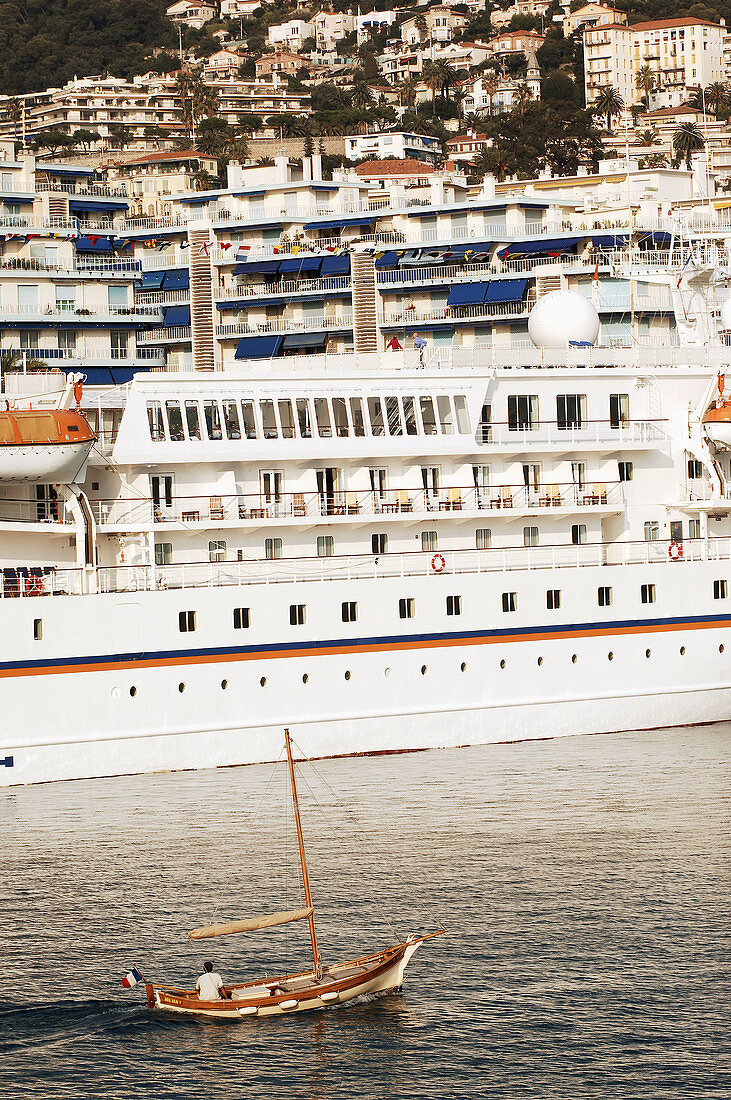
[584,17,726,109]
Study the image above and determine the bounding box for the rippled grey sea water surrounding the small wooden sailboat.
[0,725,731,1100]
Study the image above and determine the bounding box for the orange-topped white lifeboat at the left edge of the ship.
[0,409,96,484]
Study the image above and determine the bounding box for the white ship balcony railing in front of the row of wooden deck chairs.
[92,482,624,529]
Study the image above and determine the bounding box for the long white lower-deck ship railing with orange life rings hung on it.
[91,538,731,592]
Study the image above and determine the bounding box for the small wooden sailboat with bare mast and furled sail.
[140,729,444,1020]
